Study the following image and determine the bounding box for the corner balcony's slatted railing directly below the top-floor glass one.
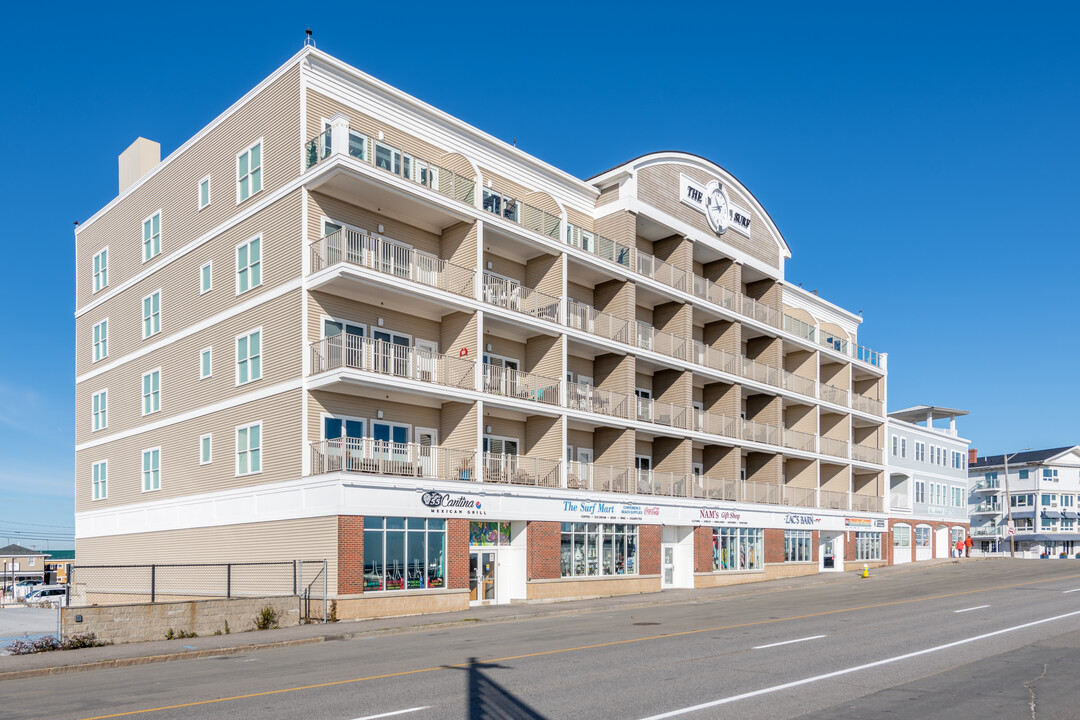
[311,229,476,298]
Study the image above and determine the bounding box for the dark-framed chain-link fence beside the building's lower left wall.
[67,560,327,620]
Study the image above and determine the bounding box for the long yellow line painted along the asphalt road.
[76,574,1080,720]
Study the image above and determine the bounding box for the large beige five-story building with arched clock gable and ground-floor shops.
[76,47,887,616]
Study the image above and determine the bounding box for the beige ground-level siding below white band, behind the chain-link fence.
[76,515,338,588]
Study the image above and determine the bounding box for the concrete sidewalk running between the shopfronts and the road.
[0,558,986,681]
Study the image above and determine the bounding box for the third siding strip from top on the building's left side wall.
[75,289,303,444]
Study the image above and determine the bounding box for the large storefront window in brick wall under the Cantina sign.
[364,517,446,593]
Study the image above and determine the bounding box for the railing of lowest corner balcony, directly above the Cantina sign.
[311,437,476,481]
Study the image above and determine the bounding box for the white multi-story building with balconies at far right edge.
[969,446,1080,558]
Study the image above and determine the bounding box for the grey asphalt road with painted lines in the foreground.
[0,560,1080,720]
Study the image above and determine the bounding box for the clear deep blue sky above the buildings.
[0,2,1080,547]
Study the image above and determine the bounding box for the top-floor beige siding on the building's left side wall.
[76,67,300,308]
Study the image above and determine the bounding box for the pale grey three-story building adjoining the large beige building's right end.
[886,405,971,563]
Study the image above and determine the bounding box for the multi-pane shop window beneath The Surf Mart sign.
[562,522,637,578]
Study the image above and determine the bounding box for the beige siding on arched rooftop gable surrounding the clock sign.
[637,164,781,268]
